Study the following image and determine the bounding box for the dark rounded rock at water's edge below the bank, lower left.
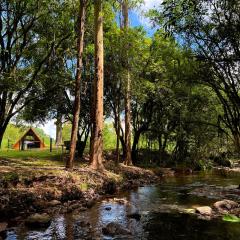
[25,213,51,228]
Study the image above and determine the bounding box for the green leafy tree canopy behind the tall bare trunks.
[0,0,236,169]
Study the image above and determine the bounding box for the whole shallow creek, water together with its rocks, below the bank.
[0,172,240,240]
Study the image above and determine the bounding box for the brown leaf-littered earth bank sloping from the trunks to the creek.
[0,159,159,222]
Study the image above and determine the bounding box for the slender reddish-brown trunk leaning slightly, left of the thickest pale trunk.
[66,0,88,169]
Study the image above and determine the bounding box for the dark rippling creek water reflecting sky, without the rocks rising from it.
[3,175,240,240]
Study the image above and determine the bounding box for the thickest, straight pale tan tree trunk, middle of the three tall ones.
[90,0,104,170]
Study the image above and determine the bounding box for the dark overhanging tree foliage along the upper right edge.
[149,0,240,153]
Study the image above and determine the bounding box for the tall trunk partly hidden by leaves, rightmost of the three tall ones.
[122,0,132,165]
